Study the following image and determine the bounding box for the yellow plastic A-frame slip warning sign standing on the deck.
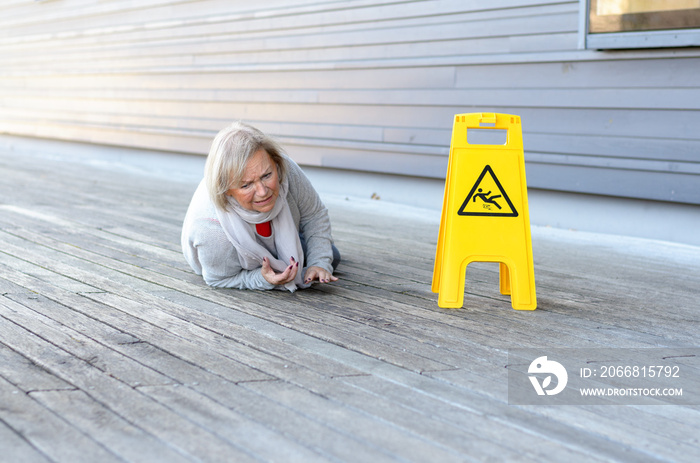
[432,113,537,310]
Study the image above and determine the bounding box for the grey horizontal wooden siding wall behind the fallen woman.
[0,0,700,204]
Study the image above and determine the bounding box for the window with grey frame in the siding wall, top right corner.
[581,0,700,49]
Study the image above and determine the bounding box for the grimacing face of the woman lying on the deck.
[226,149,279,212]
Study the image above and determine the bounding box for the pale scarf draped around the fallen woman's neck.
[215,178,309,292]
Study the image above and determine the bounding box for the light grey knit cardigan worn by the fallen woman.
[181,160,333,289]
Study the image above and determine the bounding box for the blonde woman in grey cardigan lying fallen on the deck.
[181,122,340,291]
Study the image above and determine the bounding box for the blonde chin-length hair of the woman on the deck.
[204,122,287,210]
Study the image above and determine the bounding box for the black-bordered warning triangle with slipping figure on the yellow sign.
[457,165,518,217]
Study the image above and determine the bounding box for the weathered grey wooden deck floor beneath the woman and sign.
[0,143,700,463]
